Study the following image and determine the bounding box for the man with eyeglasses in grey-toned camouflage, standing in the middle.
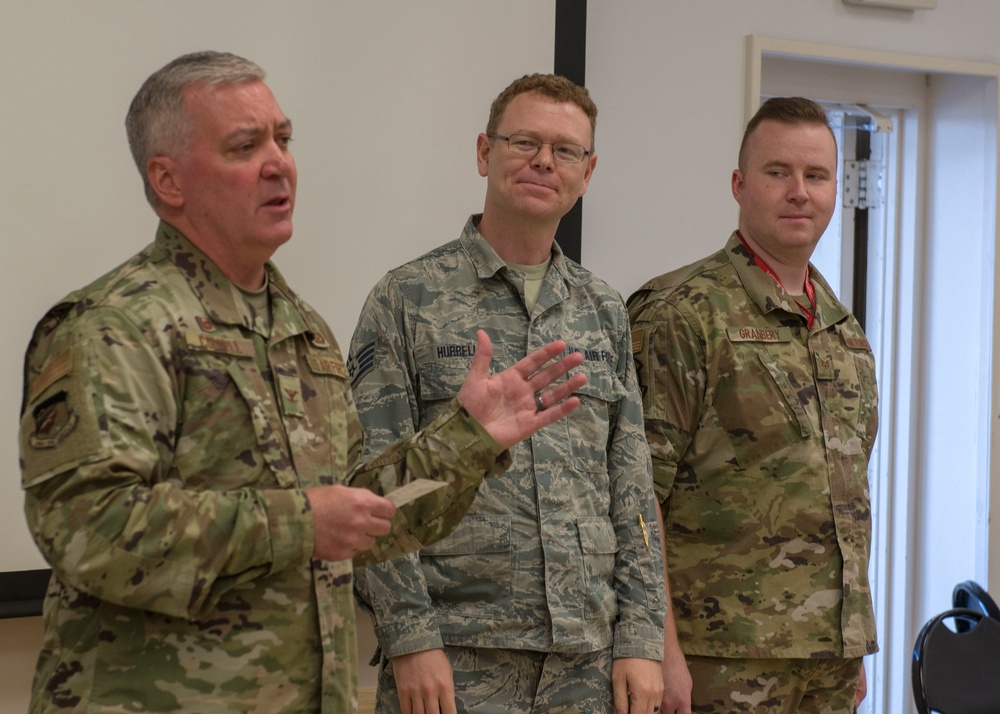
[349,74,665,714]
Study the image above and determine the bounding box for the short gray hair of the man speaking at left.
[125,52,265,208]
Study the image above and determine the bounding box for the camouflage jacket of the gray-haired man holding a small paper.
[21,223,507,713]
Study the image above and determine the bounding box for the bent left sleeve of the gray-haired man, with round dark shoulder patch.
[20,308,313,618]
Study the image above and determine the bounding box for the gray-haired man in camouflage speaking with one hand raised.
[21,53,584,714]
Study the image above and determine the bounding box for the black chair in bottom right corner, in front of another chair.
[910,608,1000,714]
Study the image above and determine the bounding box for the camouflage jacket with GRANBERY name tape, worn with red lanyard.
[628,233,878,658]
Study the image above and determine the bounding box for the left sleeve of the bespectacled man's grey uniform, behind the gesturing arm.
[349,277,450,658]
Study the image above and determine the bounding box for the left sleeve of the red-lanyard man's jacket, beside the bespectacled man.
[629,298,706,501]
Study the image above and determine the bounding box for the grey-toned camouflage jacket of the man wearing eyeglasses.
[349,216,666,660]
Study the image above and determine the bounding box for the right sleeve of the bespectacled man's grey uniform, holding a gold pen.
[608,314,666,660]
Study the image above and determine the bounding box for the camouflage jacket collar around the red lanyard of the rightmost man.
[725,231,848,331]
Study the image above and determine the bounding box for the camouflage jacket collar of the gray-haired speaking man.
[155,221,312,337]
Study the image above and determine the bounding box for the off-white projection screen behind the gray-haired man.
[0,0,555,712]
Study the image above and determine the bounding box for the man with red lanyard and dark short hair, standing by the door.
[628,98,878,714]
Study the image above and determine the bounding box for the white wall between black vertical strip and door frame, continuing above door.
[582,0,1000,297]
